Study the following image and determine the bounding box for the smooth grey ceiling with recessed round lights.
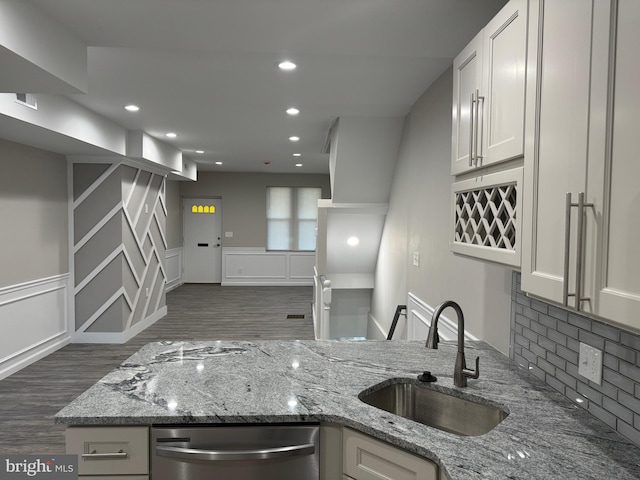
[25,0,505,173]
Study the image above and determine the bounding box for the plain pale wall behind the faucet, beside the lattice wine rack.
[369,69,511,354]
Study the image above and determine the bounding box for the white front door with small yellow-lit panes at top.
[182,198,222,283]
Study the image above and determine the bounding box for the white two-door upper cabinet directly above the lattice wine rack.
[451,0,527,175]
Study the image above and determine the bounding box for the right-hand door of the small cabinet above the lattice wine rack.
[478,0,527,166]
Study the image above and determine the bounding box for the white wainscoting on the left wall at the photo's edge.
[0,274,70,379]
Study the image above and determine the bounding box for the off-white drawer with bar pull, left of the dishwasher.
[66,427,149,474]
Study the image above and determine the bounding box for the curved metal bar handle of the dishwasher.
[156,443,316,462]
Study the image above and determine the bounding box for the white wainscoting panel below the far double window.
[222,247,315,286]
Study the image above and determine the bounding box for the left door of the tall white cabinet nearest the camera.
[522,0,592,306]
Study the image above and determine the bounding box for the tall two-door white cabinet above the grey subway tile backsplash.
[522,0,640,330]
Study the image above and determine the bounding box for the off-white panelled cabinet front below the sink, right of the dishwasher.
[343,428,438,480]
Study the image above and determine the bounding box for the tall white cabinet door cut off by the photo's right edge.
[583,0,640,330]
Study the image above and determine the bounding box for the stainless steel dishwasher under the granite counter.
[151,424,320,480]
